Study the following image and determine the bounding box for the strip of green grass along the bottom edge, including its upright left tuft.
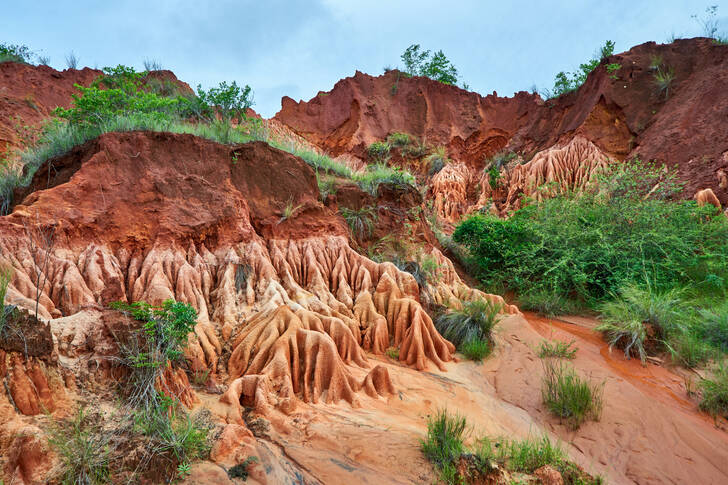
[420,410,604,485]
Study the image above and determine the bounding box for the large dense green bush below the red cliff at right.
[453,161,728,308]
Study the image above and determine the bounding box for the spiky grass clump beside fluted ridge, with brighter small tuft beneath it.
[435,299,503,360]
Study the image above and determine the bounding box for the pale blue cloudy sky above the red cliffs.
[0,0,728,117]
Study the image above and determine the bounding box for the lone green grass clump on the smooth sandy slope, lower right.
[541,361,604,429]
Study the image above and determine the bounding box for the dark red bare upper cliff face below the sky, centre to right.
[275,39,728,204]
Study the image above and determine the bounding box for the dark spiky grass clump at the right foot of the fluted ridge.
[435,299,503,348]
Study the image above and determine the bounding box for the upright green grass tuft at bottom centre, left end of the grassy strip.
[420,410,467,483]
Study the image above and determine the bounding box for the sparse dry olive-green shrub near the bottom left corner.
[48,408,111,485]
